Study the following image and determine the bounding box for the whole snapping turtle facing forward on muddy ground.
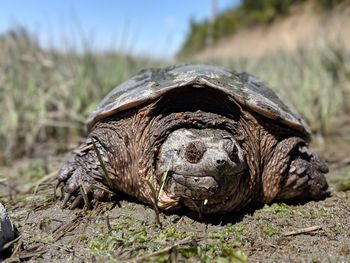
[58,65,329,216]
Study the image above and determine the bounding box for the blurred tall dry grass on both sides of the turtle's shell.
[0,26,350,163]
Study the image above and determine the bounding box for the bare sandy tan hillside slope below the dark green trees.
[195,4,350,60]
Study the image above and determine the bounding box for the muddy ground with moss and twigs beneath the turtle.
[0,139,350,262]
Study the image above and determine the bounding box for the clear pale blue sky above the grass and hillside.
[0,0,239,58]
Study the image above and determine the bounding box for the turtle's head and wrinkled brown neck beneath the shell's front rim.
[95,89,270,214]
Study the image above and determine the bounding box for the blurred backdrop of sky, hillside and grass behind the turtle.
[0,0,350,190]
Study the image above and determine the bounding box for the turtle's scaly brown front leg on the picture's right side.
[262,137,330,203]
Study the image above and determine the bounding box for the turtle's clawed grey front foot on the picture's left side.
[57,138,111,209]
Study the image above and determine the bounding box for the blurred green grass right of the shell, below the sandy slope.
[214,44,350,136]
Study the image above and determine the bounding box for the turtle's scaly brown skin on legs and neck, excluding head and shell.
[58,94,329,213]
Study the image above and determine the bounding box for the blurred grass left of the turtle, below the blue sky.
[0,28,159,163]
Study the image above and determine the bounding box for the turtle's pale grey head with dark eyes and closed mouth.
[157,128,246,212]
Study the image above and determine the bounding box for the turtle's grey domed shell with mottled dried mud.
[87,65,310,137]
